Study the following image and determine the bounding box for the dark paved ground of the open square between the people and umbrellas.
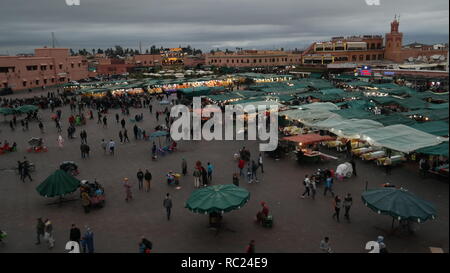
[0,90,449,253]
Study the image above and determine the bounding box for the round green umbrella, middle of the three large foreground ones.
[185,184,250,214]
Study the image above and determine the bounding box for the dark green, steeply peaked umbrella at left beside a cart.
[36,170,80,197]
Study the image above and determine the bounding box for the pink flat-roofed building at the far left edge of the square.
[0,48,88,90]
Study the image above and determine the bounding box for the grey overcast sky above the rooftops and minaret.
[0,0,449,55]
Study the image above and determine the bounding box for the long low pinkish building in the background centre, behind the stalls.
[205,50,302,68]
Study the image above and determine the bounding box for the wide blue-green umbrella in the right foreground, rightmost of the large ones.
[361,188,436,223]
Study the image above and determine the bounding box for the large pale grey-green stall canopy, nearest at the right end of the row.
[361,124,444,153]
